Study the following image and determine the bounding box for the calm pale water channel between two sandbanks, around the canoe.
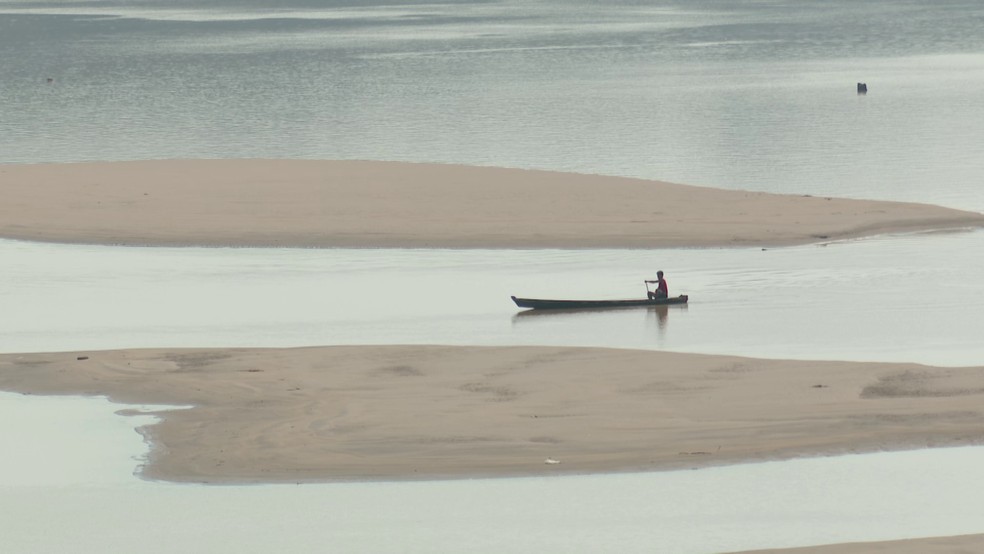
[0,231,984,365]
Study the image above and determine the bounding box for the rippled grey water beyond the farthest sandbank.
[0,0,984,211]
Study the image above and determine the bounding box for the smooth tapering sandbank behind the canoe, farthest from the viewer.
[0,160,984,248]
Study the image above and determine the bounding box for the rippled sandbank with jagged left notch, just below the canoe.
[0,346,984,482]
